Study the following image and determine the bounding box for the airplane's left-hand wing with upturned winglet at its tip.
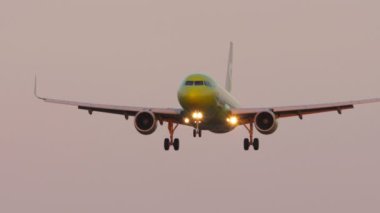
[34,77,183,123]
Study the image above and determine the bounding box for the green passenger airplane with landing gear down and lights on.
[34,42,380,151]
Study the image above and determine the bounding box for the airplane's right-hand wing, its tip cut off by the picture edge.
[231,98,380,120]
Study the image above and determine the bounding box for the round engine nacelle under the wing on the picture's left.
[135,111,157,135]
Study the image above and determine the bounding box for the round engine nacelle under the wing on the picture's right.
[255,111,278,135]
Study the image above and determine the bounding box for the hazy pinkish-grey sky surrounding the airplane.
[0,0,380,213]
